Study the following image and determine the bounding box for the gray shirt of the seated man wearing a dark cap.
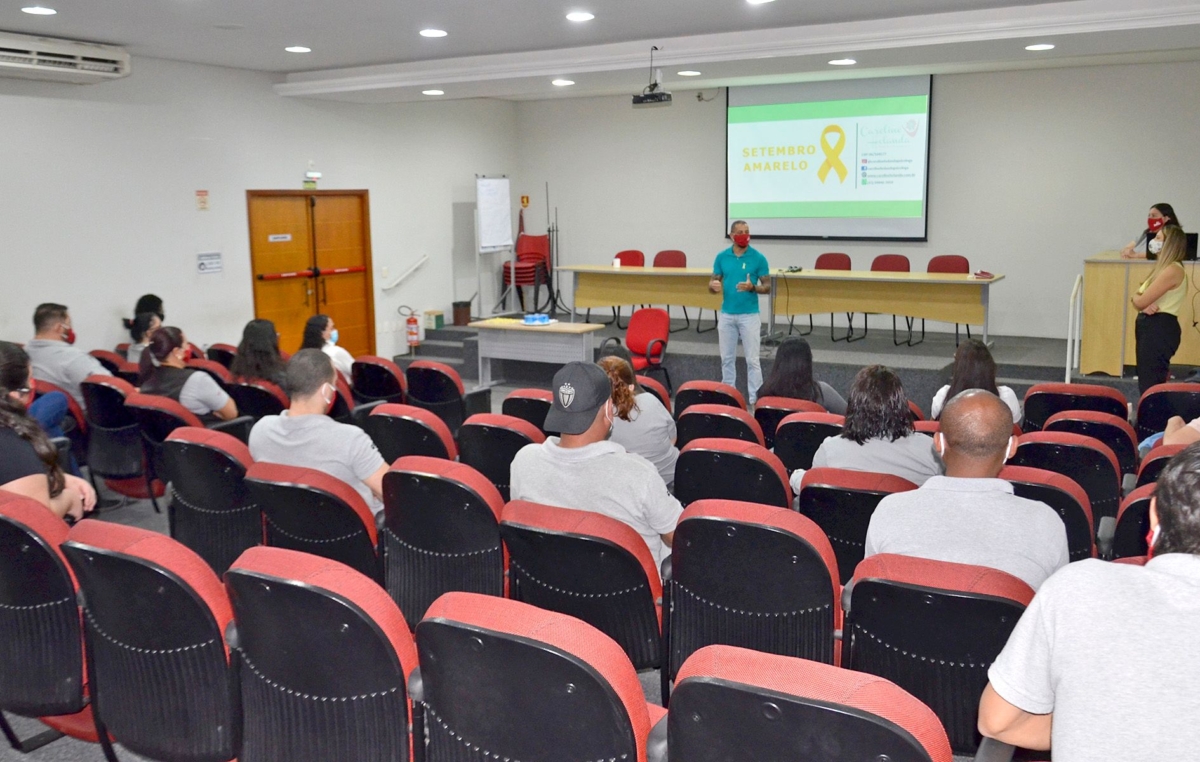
[510,437,683,566]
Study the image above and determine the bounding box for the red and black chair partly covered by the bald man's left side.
[796,468,917,584]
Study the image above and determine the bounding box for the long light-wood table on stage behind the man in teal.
[559,265,1004,342]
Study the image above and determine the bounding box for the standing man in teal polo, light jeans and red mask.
[708,220,770,404]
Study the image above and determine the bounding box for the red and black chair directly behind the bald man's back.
[842,553,1033,755]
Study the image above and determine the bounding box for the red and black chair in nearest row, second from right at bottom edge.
[414,593,666,762]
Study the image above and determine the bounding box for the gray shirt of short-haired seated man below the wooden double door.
[250,410,386,514]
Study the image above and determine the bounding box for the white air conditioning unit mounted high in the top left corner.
[0,32,131,85]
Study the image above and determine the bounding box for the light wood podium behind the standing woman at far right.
[1079,251,1200,377]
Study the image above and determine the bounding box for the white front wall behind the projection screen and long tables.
[515,58,1200,337]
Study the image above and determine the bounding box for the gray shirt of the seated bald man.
[864,476,1069,590]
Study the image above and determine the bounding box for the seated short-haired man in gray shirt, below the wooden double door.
[250,349,388,514]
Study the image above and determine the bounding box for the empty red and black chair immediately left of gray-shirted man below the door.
[162,426,263,574]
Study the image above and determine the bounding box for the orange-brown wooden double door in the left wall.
[246,191,374,356]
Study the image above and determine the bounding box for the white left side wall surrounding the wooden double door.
[0,59,516,355]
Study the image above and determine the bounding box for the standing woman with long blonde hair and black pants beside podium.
[1129,224,1188,392]
